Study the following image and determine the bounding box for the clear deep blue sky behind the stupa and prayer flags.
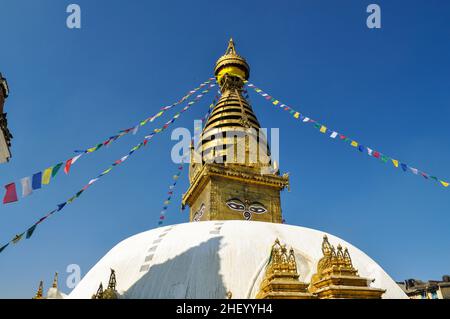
[0,0,450,298]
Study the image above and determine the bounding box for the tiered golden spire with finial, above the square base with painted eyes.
[198,39,270,167]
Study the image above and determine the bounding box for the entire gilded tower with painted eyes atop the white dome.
[183,40,289,223]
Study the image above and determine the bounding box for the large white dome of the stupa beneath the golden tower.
[68,220,407,299]
